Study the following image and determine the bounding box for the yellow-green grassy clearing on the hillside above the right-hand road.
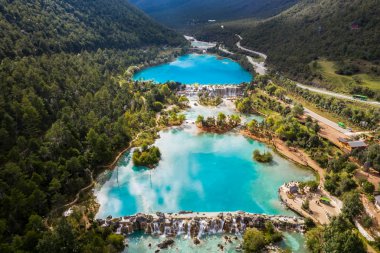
[310,60,380,93]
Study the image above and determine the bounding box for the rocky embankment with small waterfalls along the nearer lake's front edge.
[98,212,305,238]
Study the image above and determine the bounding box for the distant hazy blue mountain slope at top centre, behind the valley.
[130,0,297,27]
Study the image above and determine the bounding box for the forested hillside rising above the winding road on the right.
[198,0,380,86]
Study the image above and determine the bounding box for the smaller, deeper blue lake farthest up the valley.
[133,54,252,85]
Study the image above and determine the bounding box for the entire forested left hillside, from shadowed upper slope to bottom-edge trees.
[0,0,186,253]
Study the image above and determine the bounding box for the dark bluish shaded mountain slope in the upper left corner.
[0,0,182,58]
